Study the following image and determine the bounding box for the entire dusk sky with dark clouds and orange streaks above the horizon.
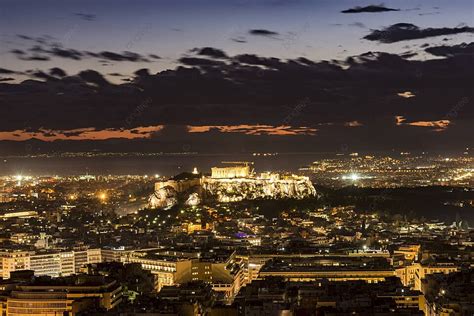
[0,0,474,152]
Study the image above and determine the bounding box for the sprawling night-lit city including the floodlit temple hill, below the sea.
[0,153,474,316]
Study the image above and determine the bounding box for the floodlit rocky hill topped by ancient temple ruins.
[149,162,316,208]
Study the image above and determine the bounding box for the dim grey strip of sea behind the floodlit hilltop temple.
[0,153,335,176]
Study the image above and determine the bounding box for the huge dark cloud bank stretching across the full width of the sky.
[0,45,474,149]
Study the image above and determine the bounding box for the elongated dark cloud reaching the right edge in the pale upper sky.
[364,23,474,43]
